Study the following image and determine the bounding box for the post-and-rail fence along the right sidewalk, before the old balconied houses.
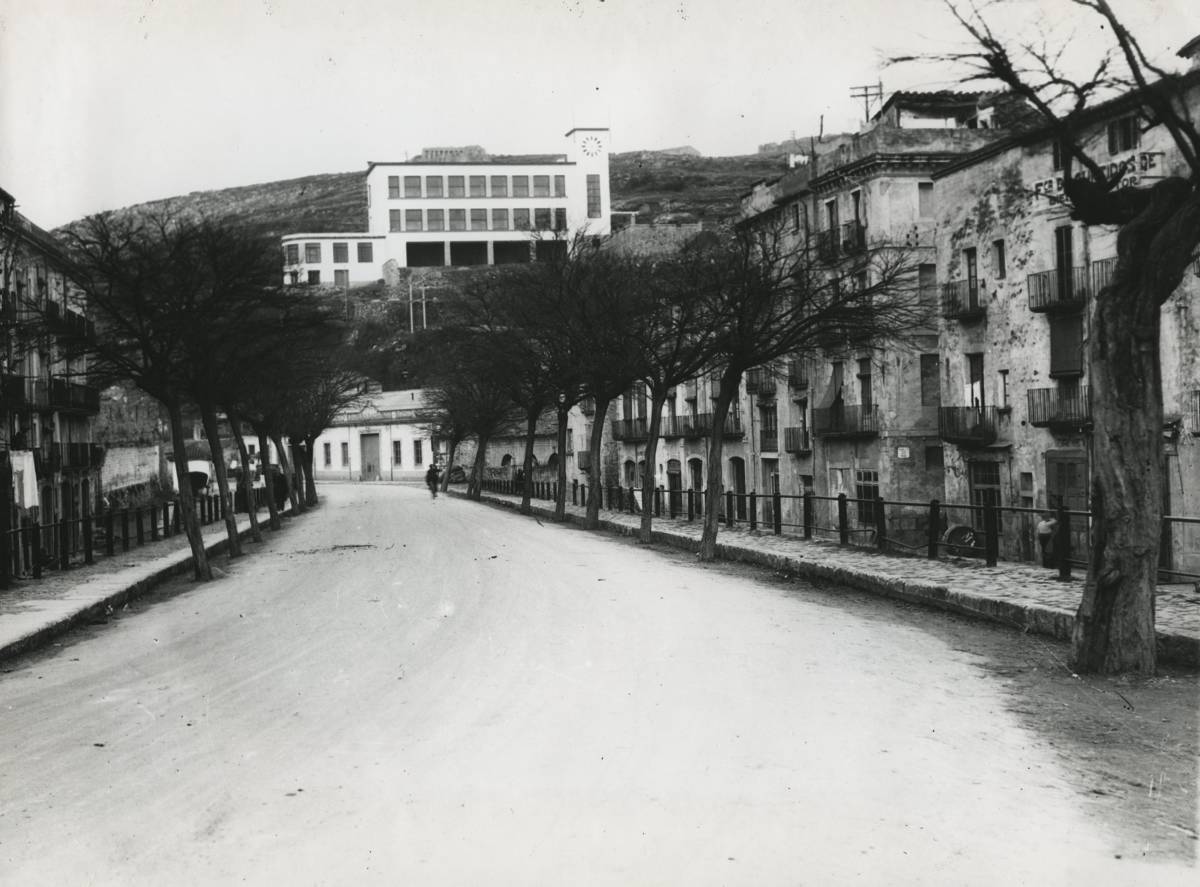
[482,479,1200,582]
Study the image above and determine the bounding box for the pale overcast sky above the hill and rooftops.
[0,0,1200,228]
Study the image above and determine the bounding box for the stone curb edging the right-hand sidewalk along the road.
[451,492,1200,669]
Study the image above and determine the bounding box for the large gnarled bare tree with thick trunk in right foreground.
[898,0,1200,675]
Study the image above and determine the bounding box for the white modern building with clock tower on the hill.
[282,127,611,287]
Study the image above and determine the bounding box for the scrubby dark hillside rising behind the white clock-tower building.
[72,149,782,238]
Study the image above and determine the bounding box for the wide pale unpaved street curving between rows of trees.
[0,485,1196,887]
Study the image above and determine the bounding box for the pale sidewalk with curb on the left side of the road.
[0,513,270,660]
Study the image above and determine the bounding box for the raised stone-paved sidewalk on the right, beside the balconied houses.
[451,491,1200,667]
